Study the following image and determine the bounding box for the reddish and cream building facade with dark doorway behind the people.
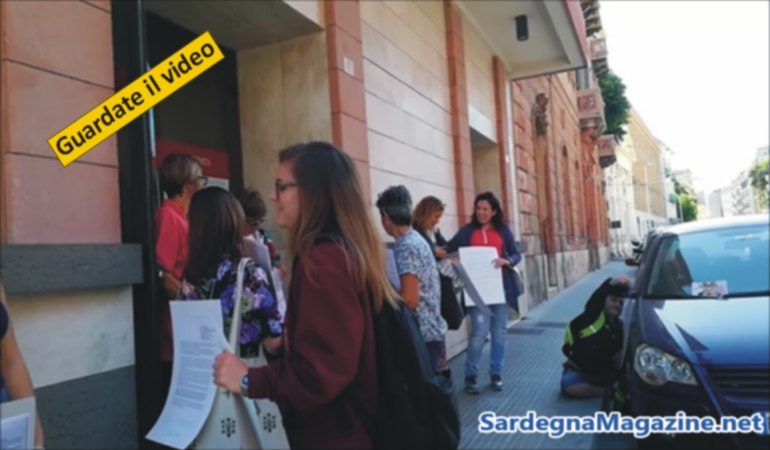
[0,0,609,448]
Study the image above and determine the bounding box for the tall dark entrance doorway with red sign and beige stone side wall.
[112,0,331,442]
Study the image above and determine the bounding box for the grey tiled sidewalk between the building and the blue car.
[449,261,635,449]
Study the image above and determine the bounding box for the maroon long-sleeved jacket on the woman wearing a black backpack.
[249,242,377,449]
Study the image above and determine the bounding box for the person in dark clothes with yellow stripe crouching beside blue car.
[561,276,631,398]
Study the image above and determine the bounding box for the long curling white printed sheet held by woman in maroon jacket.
[147,300,227,449]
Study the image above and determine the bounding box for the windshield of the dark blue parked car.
[647,225,770,298]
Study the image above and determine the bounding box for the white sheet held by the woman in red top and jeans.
[459,247,505,306]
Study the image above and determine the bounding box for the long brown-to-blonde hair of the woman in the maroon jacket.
[279,142,399,311]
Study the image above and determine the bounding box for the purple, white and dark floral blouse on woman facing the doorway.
[182,256,283,358]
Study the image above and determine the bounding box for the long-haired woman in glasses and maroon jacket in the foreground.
[214,142,397,449]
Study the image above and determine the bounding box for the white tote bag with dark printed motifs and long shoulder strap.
[191,258,289,449]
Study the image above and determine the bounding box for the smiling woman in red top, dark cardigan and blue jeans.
[446,192,521,394]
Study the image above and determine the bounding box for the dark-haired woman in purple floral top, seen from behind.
[182,187,283,357]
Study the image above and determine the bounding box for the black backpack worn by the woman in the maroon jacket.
[372,302,460,450]
